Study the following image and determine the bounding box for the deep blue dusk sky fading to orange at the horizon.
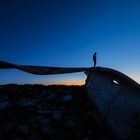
[0,0,140,85]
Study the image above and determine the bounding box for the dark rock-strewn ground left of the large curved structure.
[0,85,111,140]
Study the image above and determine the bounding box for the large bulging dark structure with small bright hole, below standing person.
[86,67,140,140]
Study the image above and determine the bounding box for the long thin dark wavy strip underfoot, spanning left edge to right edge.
[0,61,140,89]
